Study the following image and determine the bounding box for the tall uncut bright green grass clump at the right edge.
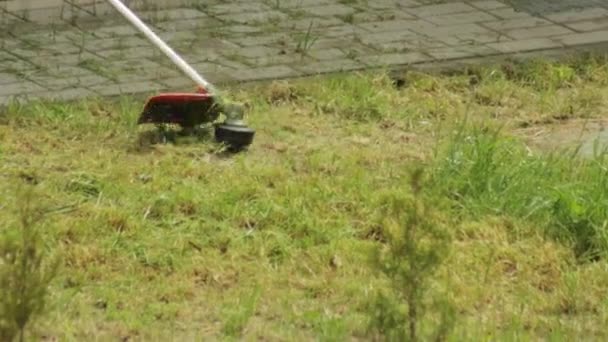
[433,127,608,259]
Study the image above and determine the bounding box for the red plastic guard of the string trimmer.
[137,93,219,127]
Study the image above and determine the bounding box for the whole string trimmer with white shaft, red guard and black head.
[108,0,255,150]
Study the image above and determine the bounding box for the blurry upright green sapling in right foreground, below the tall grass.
[369,169,453,341]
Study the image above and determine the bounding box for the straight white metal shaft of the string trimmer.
[108,0,217,95]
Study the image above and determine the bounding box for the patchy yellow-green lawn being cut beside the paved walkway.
[0,53,608,341]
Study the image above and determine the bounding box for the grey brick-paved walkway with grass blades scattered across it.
[0,0,608,103]
